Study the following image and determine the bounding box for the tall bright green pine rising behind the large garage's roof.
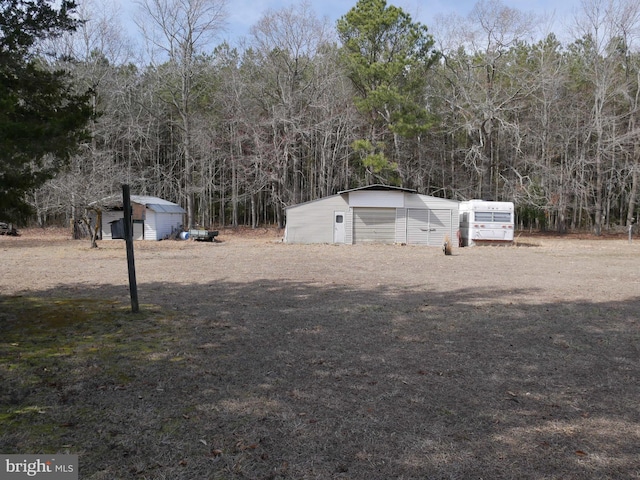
[337,0,439,186]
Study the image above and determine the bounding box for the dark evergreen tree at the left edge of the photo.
[0,0,91,221]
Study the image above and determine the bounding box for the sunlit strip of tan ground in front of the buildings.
[0,229,640,302]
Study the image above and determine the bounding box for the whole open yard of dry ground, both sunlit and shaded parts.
[0,230,640,480]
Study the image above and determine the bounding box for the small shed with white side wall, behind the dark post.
[100,195,186,240]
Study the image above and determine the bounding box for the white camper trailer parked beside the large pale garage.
[460,200,514,247]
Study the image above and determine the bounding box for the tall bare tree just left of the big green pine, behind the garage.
[251,3,335,222]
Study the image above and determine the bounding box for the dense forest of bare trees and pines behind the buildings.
[28,0,640,234]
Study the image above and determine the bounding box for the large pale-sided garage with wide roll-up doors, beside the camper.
[284,185,459,247]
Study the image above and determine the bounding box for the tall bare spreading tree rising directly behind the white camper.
[443,0,536,199]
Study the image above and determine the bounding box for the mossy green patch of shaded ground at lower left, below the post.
[0,296,171,453]
